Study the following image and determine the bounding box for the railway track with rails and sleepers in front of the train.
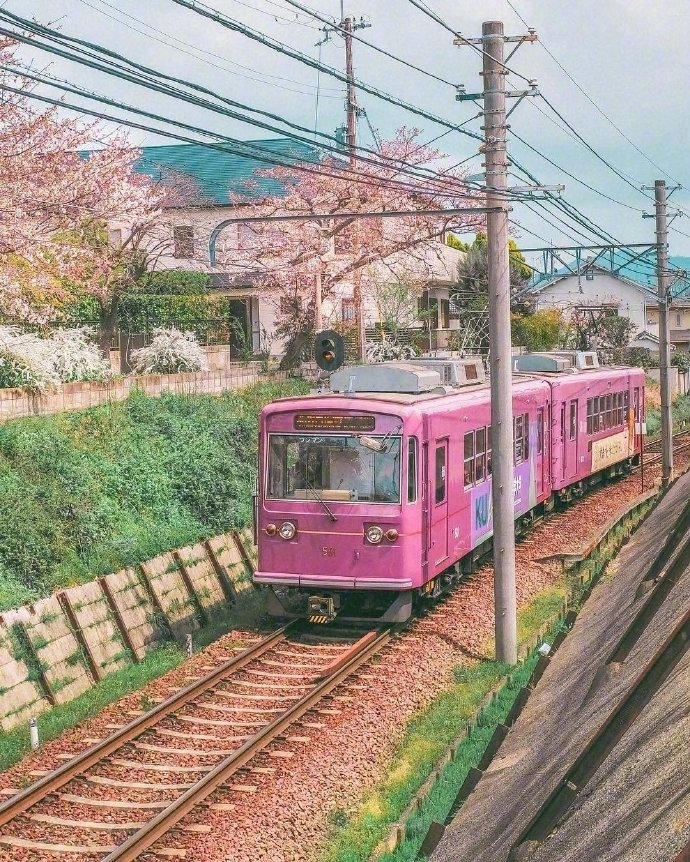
[0,623,394,862]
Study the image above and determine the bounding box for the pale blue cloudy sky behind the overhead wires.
[5,0,690,274]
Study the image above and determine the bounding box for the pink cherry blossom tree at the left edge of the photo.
[0,41,164,344]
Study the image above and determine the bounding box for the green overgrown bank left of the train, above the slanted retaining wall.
[0,381,306,611]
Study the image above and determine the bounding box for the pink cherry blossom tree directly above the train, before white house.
[217,129,484,358]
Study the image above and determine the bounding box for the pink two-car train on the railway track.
[254,352,644,622]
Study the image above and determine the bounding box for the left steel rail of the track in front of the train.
[0,622,295,826]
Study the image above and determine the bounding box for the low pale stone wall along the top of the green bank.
[0,362,284,422]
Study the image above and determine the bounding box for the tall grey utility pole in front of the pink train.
[482,21,517,664]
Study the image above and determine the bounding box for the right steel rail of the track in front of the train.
[103,628,394,862]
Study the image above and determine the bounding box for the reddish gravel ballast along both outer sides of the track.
[0,456,676,862]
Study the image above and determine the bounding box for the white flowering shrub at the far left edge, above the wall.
[0,326,60,392]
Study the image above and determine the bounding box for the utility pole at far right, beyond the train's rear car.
[654,180,673,488]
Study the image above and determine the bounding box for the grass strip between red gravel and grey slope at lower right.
[321,587,566,862]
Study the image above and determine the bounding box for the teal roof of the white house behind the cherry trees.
[134,138,320,204]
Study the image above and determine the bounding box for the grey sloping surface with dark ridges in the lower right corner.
[431,474,690,862]
